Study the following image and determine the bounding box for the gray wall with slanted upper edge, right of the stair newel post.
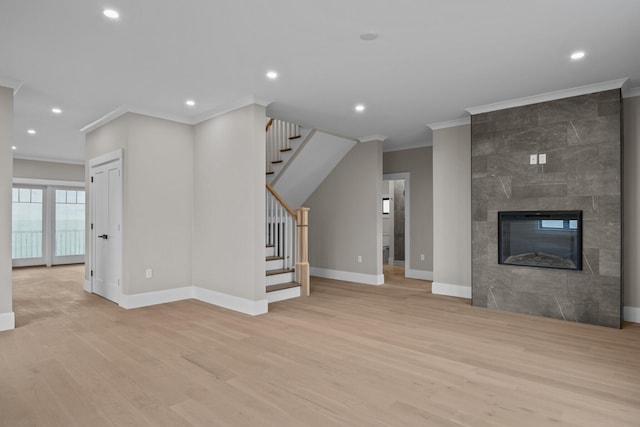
[303,141,382,276]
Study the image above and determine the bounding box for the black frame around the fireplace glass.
[497,210,583,270]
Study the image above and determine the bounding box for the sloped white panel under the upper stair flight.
[271,129,358,211]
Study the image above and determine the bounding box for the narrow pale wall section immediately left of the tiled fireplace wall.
[432,125,471,298]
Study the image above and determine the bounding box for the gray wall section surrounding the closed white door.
[86,114,193,295]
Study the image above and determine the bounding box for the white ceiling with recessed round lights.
[0,0,640,162]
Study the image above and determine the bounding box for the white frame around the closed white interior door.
[90,148,124,305]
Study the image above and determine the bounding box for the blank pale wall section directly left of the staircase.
[193,105,266,301]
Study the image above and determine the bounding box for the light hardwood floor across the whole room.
[0,266,640,427]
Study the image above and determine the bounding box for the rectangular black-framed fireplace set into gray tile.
[498,211,582,270]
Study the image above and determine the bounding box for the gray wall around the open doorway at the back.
[383,147,433,273]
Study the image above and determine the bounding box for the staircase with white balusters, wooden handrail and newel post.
[265,119,358,303]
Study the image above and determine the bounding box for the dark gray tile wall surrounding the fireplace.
[471,90,622,328]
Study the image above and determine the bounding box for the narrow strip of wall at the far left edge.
[0,87,13,323]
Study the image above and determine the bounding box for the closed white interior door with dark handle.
[90,152,122,303]
